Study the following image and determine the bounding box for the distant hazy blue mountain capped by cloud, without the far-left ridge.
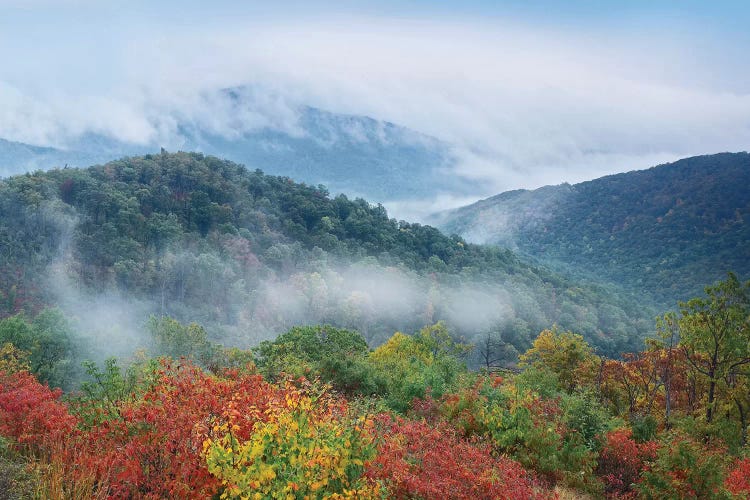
[181,101,477,202]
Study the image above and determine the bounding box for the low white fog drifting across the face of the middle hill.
[45,236,528,361]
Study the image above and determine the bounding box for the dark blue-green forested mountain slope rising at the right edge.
[431,152,750,306]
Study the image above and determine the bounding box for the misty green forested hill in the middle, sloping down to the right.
[0,152,655,362]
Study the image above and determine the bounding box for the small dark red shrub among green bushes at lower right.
[596,429,658,498]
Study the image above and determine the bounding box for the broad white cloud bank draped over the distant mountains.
[0,13,750,191]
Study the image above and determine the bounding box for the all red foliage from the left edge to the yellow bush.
[0,364,298,498]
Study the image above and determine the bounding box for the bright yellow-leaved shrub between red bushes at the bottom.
[203,390,379,498]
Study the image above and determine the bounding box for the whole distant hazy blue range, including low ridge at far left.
[0,101,479,202]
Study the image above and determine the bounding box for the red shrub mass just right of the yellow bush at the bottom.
[366,415,544,499]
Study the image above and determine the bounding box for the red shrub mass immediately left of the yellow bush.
[81,364,283,498]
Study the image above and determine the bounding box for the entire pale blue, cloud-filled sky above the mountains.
[0,0,750,192]
